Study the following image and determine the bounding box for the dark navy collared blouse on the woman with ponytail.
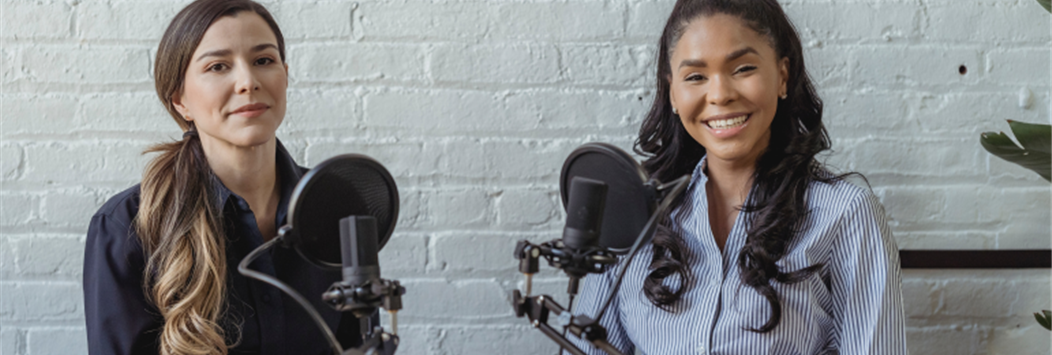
[84,142,368,355]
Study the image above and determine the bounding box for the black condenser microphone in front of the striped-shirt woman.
[563,176,607,250]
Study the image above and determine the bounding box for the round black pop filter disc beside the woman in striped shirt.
[559,143,656,254]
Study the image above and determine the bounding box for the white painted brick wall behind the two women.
[0,0,1052,355]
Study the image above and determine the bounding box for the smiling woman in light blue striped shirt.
[578,0,907,355]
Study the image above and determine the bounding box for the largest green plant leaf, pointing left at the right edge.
[979,120,1052,182]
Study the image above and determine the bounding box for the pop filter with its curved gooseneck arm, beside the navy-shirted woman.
[238,154,404,355]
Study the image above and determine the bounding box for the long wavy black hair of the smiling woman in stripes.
[635,0,843,333]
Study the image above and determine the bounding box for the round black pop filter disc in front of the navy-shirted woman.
[285,154,399,270]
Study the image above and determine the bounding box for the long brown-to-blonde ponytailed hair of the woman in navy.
[136,0,285,355]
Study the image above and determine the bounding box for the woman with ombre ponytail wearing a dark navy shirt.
[84,0,361,355]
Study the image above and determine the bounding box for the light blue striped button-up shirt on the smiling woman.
[569,159,907,355]
